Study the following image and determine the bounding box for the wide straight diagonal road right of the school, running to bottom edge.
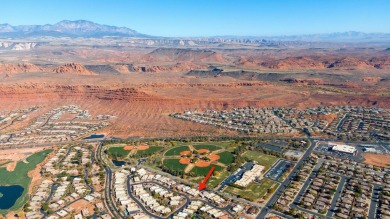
[256,138,315,219]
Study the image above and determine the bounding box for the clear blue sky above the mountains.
[0,0,390,36]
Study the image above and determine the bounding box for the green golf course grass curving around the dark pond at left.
[0,149,53,214]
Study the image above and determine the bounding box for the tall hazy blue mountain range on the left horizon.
[0,20,149,38]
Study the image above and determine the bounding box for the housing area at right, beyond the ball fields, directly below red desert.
[171,106,390,140]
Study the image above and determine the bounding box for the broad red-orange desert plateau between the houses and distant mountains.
[0,26,390,137]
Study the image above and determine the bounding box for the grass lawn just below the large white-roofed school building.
[224,178,277,201]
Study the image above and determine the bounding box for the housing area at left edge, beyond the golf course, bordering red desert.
[0,105,112,147]
